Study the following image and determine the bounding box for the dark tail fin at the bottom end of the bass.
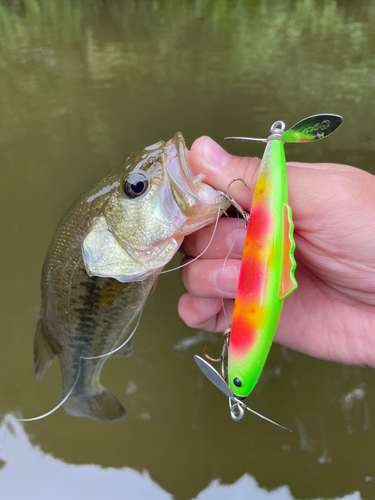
[64,386,126,422]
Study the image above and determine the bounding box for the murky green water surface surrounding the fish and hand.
[0,0,375,500]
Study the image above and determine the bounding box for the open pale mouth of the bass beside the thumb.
[164,132,228,218]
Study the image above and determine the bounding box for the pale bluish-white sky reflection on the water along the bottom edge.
[0,419,361,500]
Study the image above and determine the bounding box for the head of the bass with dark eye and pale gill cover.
[82,132,229,282]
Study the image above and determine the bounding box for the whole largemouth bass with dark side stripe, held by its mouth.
[34,132,228,420]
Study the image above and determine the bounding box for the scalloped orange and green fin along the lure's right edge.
[280,205,298,300]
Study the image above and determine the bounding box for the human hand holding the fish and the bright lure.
[179,137,375,367]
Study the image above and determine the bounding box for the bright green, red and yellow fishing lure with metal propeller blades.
[194,114,343,430]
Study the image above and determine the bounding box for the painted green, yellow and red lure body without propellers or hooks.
[228,129,297,397]
